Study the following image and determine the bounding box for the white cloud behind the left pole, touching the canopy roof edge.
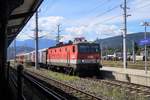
[17,16,64,41]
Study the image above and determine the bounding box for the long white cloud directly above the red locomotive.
[62,24,121,41]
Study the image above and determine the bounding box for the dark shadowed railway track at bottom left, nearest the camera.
[9,68,68,100]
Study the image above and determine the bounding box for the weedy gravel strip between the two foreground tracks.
[26,68,150,100]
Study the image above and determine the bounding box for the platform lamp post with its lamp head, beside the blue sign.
[141,22,150,74]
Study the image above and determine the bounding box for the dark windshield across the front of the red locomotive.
[79,44,99,53]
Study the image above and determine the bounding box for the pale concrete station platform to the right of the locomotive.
[101,66,150,86]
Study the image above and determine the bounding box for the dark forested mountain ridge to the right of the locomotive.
[96,32,150,49]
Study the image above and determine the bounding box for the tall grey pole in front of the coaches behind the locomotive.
[35,11,38,69]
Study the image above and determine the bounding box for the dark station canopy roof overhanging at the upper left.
[7,0,43,45]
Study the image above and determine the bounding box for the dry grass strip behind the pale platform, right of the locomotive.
[102,60,150,70]
